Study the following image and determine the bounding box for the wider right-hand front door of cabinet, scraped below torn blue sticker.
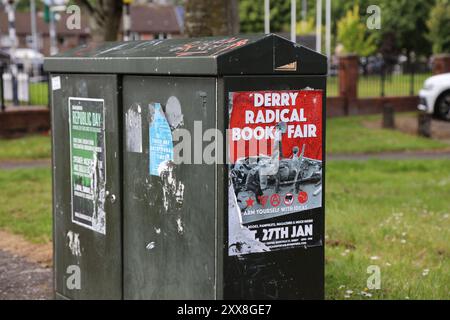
[123,76,216,299]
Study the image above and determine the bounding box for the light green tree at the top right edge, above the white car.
[427,0,450,53]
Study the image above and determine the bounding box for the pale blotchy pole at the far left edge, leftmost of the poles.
[4,0,19,106]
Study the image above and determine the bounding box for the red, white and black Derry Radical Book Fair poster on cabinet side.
[228,89,322,255]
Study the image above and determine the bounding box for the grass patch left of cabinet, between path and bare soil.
[0,168,52,242]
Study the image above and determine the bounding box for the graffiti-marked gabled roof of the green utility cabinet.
[45,34,327,75]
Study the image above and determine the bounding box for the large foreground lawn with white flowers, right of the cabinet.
[325,160,450,299]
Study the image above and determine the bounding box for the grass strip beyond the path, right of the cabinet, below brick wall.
[327,115,450,153]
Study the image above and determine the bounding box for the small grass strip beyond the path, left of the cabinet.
[0,135,51,160]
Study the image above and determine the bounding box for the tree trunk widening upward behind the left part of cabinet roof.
[76,0,123,42]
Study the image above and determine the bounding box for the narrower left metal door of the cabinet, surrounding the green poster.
[52,74,122,299]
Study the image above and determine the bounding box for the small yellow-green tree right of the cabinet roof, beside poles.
[337,5,377,57]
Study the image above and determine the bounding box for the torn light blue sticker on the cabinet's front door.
[149,103,173,176]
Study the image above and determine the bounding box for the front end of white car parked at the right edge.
[418,73,450,120]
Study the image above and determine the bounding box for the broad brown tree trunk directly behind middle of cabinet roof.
[186,0,239,37]
